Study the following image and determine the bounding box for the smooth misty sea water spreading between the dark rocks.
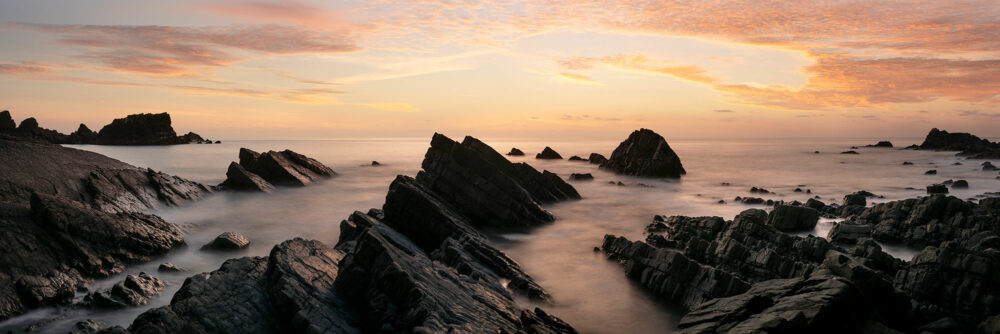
[0,137,1000,333]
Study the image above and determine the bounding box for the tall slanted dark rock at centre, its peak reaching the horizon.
[416,134,580,228]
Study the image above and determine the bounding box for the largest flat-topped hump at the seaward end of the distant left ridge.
[93,113,204,145]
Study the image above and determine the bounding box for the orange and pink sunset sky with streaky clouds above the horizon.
[0,0,1000,139]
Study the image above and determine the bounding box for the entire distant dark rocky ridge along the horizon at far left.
[0,110,213,145]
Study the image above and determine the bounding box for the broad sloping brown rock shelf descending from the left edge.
[0,136,209,320]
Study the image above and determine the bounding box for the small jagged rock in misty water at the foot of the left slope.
[85,273,166,308]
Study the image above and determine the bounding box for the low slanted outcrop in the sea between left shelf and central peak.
[219,148,337,192]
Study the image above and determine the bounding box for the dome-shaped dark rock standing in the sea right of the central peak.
[601,129,687,178]
